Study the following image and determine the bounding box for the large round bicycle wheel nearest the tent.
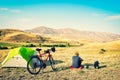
[27,56,42,74]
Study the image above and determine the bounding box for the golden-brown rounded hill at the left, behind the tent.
[0,29,45,42]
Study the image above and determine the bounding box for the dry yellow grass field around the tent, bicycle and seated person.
[0,42,120,80]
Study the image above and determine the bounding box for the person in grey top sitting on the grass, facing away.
[72,52,83,68]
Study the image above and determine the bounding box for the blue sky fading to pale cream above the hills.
[0,0,120,34]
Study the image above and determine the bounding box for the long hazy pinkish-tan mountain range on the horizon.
[27,26,120,42]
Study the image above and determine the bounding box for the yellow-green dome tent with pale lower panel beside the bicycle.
[2,47,35,67]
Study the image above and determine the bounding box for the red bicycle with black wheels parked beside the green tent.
[27,48,56,74]
